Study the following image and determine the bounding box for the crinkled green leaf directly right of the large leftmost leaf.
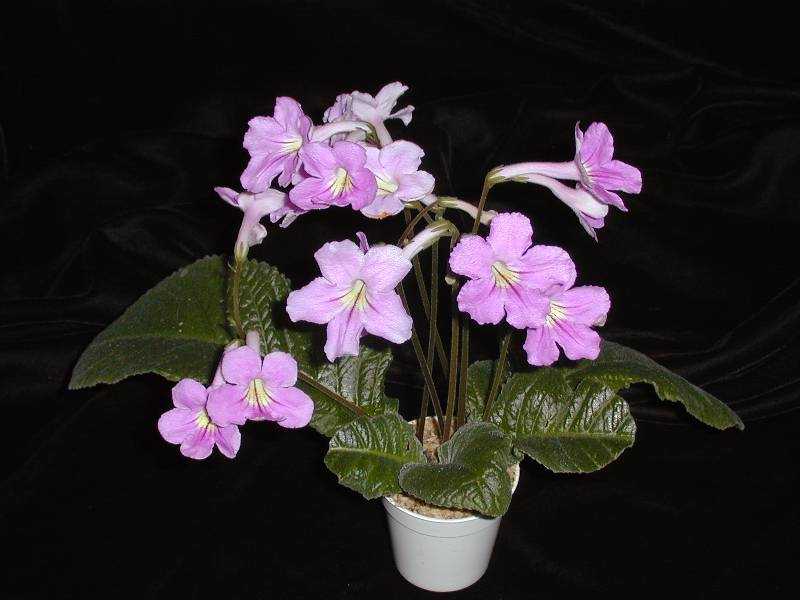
[233,260,315,375]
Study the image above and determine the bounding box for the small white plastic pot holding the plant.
[383,467,519,592]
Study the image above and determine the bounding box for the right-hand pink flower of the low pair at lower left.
[208,346,314,428]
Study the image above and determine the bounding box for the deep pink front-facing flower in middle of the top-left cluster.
[289,142,377,210]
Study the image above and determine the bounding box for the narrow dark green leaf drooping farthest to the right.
[567,341,744,429]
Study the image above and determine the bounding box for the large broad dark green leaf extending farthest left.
[69,256,230,389]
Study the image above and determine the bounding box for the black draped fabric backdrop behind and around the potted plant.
[0,0,800,599]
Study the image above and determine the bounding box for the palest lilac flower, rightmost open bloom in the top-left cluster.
[361,140,434,219]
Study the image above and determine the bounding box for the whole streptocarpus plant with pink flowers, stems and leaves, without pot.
[70,83,742,516]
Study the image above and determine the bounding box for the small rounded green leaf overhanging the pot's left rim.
[325,414,425,499]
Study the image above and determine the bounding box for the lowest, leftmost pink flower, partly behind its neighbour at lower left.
[158,379,242,460]
